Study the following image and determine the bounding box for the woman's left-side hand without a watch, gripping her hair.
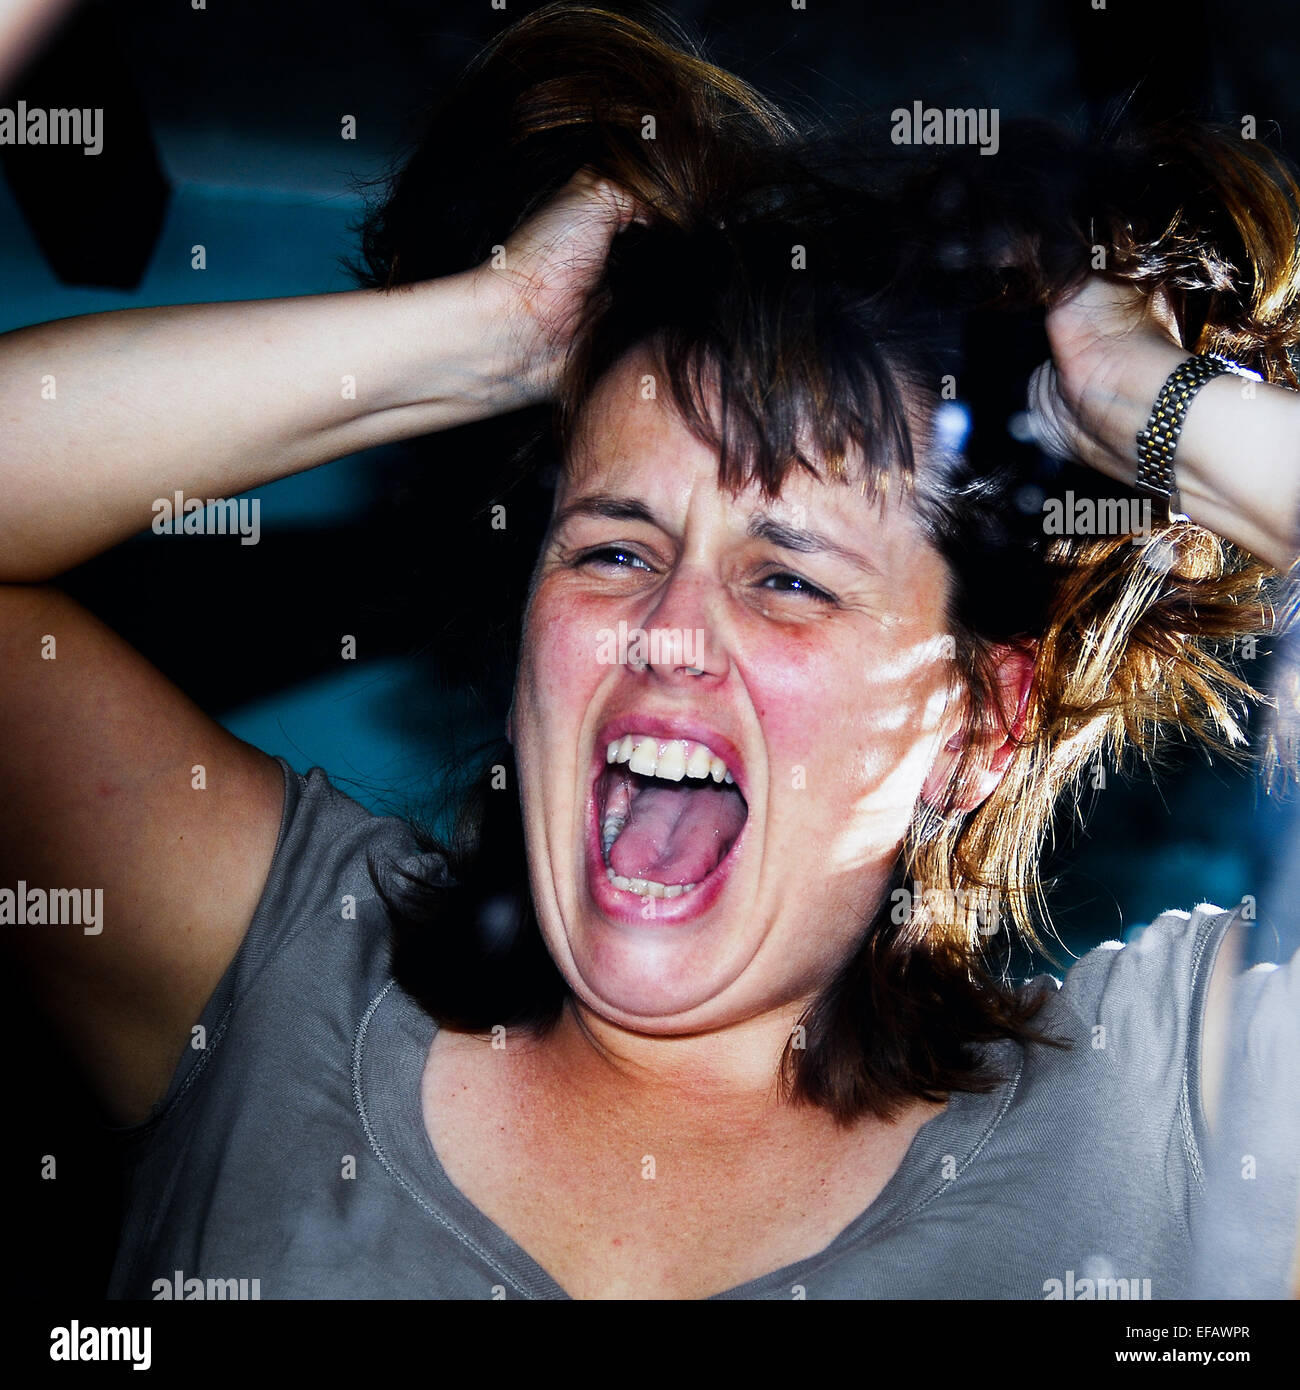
[471,170,638,400]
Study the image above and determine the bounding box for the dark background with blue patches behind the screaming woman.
[0,0,1300,1297]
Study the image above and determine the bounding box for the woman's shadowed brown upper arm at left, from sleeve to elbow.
[0,584,284,1123]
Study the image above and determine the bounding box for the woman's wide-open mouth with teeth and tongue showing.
[595,734,749,898]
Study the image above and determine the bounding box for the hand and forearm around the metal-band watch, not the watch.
[1027,275,1300,570]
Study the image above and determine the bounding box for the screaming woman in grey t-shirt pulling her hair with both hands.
[0,6,1300,1298]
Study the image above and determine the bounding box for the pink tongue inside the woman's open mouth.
[609,784,745,884]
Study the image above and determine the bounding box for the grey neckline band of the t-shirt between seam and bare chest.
[352,980,1023,1300]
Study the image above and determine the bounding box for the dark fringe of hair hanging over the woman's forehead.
[558,228,925,499]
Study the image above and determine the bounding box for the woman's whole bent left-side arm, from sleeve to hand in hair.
[0,168,630,1122]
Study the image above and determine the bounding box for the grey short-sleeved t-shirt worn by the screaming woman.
[110,765,1300,1298]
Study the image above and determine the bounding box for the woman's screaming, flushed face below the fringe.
[510,357,961,1034]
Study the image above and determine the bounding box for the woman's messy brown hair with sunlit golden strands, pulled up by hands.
[347,4,1300,1123]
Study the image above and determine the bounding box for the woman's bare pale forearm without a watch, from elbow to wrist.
[0,274,539,582]
